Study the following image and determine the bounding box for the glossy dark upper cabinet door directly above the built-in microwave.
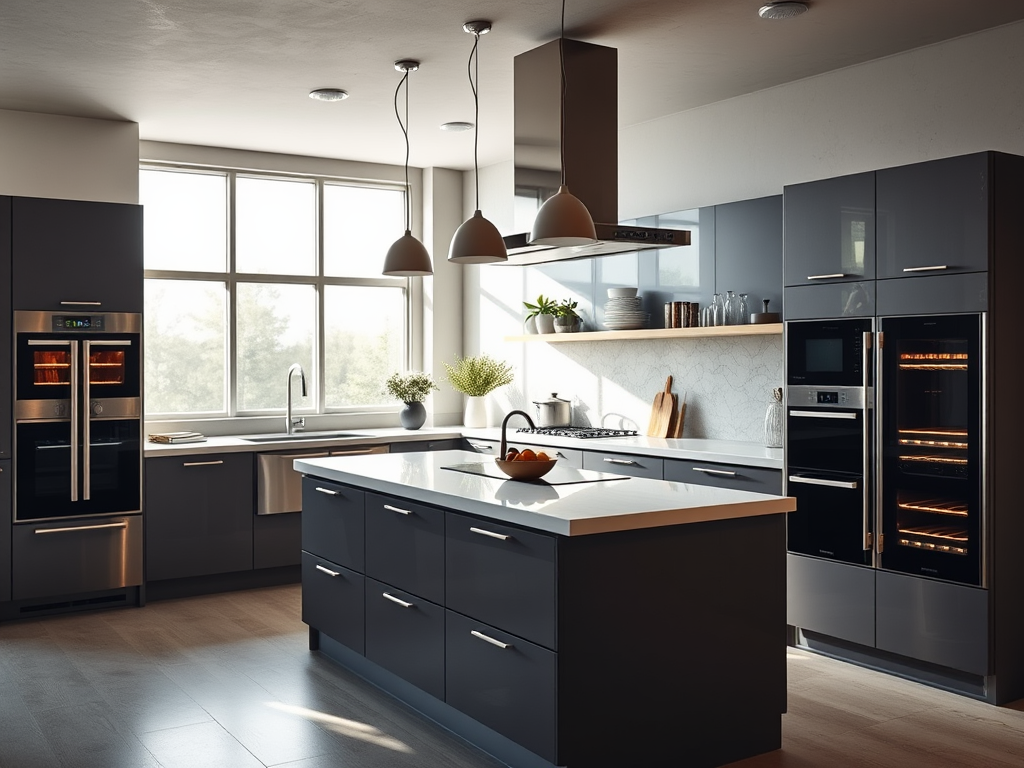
[782,172,874,286]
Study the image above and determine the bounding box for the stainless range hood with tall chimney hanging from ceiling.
[502,39,690,264]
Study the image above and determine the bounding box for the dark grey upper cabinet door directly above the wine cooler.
[876,153,991,279]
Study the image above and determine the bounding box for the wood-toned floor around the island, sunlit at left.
[0,586,1024,768]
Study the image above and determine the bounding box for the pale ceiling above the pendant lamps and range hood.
[6,0,1024,168]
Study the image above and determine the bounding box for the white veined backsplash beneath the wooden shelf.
[494,336,783,442]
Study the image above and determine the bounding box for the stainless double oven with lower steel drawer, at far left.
[13,311,142,600]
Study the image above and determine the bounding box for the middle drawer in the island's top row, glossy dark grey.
[366,494,444,603]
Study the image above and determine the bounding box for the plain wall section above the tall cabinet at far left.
[0,110,138,203]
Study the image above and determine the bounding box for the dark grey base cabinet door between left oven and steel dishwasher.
[144,454,254,581]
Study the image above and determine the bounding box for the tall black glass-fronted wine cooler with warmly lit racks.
[877,314,984,585]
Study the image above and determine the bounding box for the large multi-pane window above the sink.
[139,167,410,418]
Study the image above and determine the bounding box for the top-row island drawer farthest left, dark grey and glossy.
[302,477,366,571]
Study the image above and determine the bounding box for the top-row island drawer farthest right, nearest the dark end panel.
[444,512,555,648]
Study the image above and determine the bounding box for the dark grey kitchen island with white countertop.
[295,451,794,768]
